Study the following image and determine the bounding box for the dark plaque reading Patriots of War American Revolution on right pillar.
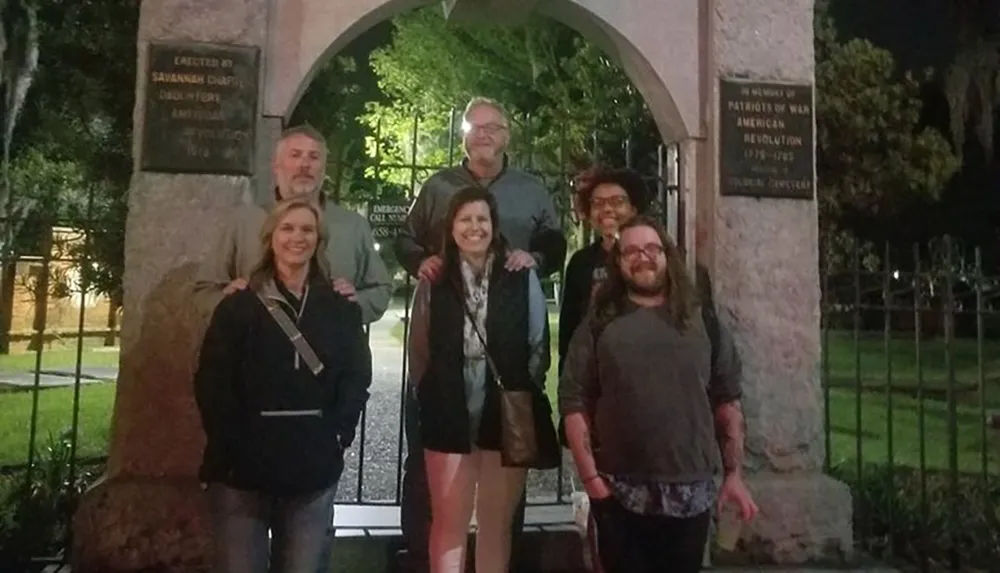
[719,79,816,199]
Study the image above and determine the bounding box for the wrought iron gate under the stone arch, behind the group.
[328,110,683,505]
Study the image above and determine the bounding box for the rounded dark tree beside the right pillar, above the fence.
[815,4,959,265]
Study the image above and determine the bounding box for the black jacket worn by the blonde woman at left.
[194,280,372,495]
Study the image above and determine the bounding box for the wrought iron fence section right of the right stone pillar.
[822,237,1000,571]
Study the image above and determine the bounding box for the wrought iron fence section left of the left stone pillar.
[0,181,114,567]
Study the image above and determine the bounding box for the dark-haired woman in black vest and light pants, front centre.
[408,187,549,573]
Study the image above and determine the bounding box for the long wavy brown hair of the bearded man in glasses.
[591,215,699,332]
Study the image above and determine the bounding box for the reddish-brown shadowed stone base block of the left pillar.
[72,477,212,573]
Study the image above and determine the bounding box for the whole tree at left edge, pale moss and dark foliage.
[0,0,139,352]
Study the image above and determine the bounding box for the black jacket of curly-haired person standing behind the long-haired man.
[559,239,608,375]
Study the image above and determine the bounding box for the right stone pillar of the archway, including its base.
[696,0,852,563]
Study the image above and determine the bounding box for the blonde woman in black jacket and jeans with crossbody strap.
[194,199,371,573]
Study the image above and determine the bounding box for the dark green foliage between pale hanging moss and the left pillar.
[14,0,139,301]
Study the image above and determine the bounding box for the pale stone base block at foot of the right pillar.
[713,472,855,565]
